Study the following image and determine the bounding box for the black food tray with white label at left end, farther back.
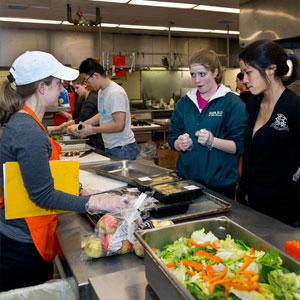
[135,173,182,192]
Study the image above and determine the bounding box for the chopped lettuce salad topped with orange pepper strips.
[153,229,300,300]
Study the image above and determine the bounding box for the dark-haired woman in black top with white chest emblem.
[237,40,300,226]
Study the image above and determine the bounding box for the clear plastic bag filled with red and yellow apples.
[81,193,156,260]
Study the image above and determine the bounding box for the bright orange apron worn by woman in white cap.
[0,105,61,262]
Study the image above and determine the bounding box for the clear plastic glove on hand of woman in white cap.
[86,193,129,214]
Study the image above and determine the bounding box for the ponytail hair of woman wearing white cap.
[0,74,54,126]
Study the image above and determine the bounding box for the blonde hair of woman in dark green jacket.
[190,49,222,83]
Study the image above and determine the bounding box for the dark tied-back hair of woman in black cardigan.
[239,40,300,85]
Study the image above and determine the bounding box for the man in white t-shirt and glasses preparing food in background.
[78,58,138,160]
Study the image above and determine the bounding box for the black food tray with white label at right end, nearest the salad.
[153,180,204,204]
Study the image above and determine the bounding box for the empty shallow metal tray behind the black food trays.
[94,160,172,186]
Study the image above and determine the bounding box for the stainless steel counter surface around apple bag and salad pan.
[57,190,300,300]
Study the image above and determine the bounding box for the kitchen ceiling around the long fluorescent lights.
[0,0,239,38]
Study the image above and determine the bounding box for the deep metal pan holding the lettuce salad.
[135,217,300,300]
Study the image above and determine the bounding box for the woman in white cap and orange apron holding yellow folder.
[0,51,126,292]
